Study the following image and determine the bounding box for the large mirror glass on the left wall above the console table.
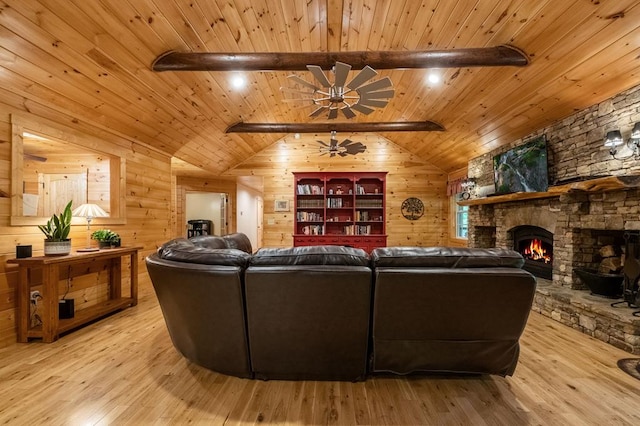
[11,114,126,225]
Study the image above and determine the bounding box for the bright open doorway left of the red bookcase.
[184,192,229,236]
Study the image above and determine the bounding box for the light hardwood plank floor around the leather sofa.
[0,285,640,425]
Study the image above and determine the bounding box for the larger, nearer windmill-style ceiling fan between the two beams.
[280,62,395,119]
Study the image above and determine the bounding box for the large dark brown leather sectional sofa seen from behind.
[146,234,536,381]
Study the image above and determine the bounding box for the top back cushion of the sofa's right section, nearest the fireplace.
[371,247,524,268]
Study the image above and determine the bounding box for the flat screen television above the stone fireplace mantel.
[493,135,549,194]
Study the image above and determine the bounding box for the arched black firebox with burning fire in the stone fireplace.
[513,225,553,280]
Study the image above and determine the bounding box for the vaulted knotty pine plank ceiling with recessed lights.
[0,0,640,174]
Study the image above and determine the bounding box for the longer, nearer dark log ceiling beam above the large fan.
[151,45,529,71]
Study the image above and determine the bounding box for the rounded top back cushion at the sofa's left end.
[158,238,251,268]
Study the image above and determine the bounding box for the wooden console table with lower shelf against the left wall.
[7,247,142,343]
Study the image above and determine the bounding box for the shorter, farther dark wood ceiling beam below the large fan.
[225,121,444,133]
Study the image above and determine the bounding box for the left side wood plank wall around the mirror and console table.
[0,105,172,347]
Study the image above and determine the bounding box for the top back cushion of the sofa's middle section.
[251,245,370,266]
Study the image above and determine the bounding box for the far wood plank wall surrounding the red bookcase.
[229,134,449,247]
